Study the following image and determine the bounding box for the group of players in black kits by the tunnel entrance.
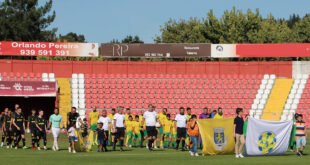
[1,104,47,150]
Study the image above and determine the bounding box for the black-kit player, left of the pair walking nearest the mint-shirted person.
[27,109,38,150]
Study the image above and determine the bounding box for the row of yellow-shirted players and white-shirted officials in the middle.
[82,105,192,151]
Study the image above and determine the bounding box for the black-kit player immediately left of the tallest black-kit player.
[2,109,14,148]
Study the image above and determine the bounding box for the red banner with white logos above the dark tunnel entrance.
[0,81,57,97]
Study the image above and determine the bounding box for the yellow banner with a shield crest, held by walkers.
[197,118,235,155]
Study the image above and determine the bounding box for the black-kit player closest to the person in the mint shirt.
[36,110,47,150]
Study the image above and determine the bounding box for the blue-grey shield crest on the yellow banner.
[212,127,228,150]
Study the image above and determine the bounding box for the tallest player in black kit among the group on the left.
[10,108,27,149]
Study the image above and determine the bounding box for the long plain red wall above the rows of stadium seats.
[0,60,292,78]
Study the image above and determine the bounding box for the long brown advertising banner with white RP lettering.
[101,44,211,58]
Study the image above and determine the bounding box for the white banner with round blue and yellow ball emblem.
[245,117,293,156]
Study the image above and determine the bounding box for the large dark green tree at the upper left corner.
[0,0,57,41]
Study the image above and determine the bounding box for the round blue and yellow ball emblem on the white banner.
[258,132,277,154]
